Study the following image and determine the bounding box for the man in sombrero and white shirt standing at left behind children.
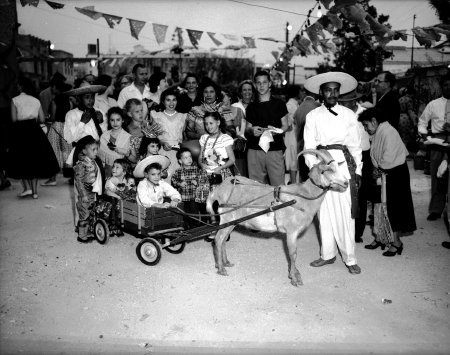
[64,82,107,166]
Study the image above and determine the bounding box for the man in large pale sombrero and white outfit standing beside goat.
[304,72,362,274]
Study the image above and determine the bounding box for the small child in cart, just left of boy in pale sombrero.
[105,159,136,200]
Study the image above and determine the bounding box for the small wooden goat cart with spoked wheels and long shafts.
[93,200,296,266]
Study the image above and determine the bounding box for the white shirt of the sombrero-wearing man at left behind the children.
[64,108,107,144]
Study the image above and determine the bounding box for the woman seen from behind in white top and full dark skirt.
[7,78,59,199]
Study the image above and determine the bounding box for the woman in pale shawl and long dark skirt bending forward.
[358,108,416,256]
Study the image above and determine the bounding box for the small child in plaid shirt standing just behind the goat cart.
[171,148,202,229]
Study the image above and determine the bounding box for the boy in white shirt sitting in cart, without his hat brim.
[137,163,181,208]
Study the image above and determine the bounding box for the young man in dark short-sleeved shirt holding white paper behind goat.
[245,70,289,186]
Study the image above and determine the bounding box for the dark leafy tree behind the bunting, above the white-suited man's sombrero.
[334,0,392,81]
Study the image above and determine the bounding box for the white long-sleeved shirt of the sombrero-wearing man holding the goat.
[304,105,362,179]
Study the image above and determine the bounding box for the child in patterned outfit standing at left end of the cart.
[73,136,103,243]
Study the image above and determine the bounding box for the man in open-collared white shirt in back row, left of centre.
[117,64,151,117]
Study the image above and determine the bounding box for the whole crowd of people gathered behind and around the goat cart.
[0,64,450,264]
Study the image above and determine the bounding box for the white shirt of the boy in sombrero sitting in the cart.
[137,179,181,207]
